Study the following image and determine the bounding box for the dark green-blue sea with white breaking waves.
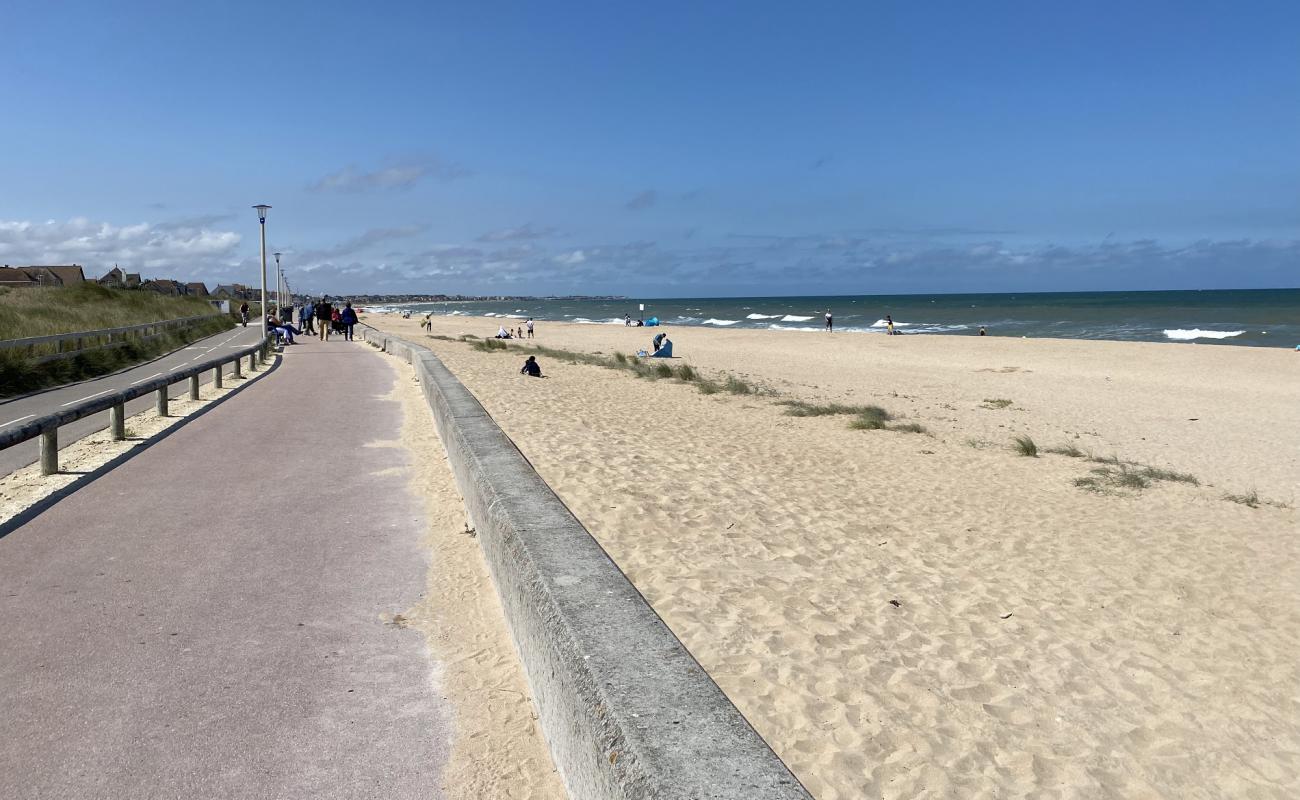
[368,289,1300,347]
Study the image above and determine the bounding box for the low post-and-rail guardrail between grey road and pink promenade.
[0,336,272,475]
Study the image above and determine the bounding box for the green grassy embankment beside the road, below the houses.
[0,284,237,397]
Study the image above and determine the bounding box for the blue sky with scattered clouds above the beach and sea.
[0,0,1300,297]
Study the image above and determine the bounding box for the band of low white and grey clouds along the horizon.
[0,215,1300,297]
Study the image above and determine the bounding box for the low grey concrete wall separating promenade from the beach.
[358,325,811,800]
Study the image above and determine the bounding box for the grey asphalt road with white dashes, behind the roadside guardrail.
[0,325,261,475]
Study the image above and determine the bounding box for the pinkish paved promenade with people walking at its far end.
[0,337,450,799]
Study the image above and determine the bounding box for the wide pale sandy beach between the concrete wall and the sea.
[368,316,1300,800]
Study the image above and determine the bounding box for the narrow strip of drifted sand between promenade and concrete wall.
[390,366,567,800]
